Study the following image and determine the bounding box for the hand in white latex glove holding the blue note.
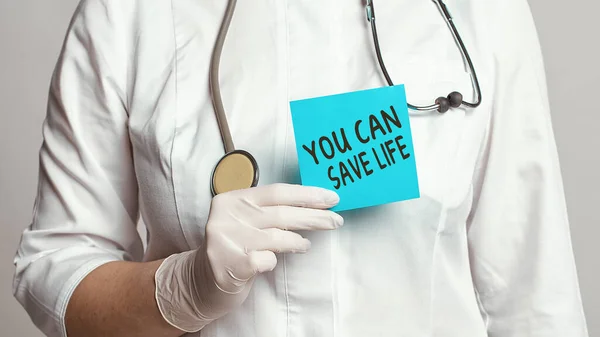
[155,184,343,332]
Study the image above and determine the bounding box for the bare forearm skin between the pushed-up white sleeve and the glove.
[65,261,183,337]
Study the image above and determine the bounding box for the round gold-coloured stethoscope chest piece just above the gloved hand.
[211,150,258,195]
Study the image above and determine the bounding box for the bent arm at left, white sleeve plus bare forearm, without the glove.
[14,0,181,337]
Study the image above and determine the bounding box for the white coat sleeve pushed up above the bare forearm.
[13,0,143,336]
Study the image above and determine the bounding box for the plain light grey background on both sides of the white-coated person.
[0,0,600,337]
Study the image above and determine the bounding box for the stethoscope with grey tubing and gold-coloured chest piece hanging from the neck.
[209,0,481,196]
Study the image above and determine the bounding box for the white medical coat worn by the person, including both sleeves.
[14,0,587,337]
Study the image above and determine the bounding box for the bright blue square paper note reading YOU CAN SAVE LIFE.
[290,85,420,211]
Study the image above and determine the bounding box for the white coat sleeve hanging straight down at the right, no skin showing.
[468,0,588,337]
